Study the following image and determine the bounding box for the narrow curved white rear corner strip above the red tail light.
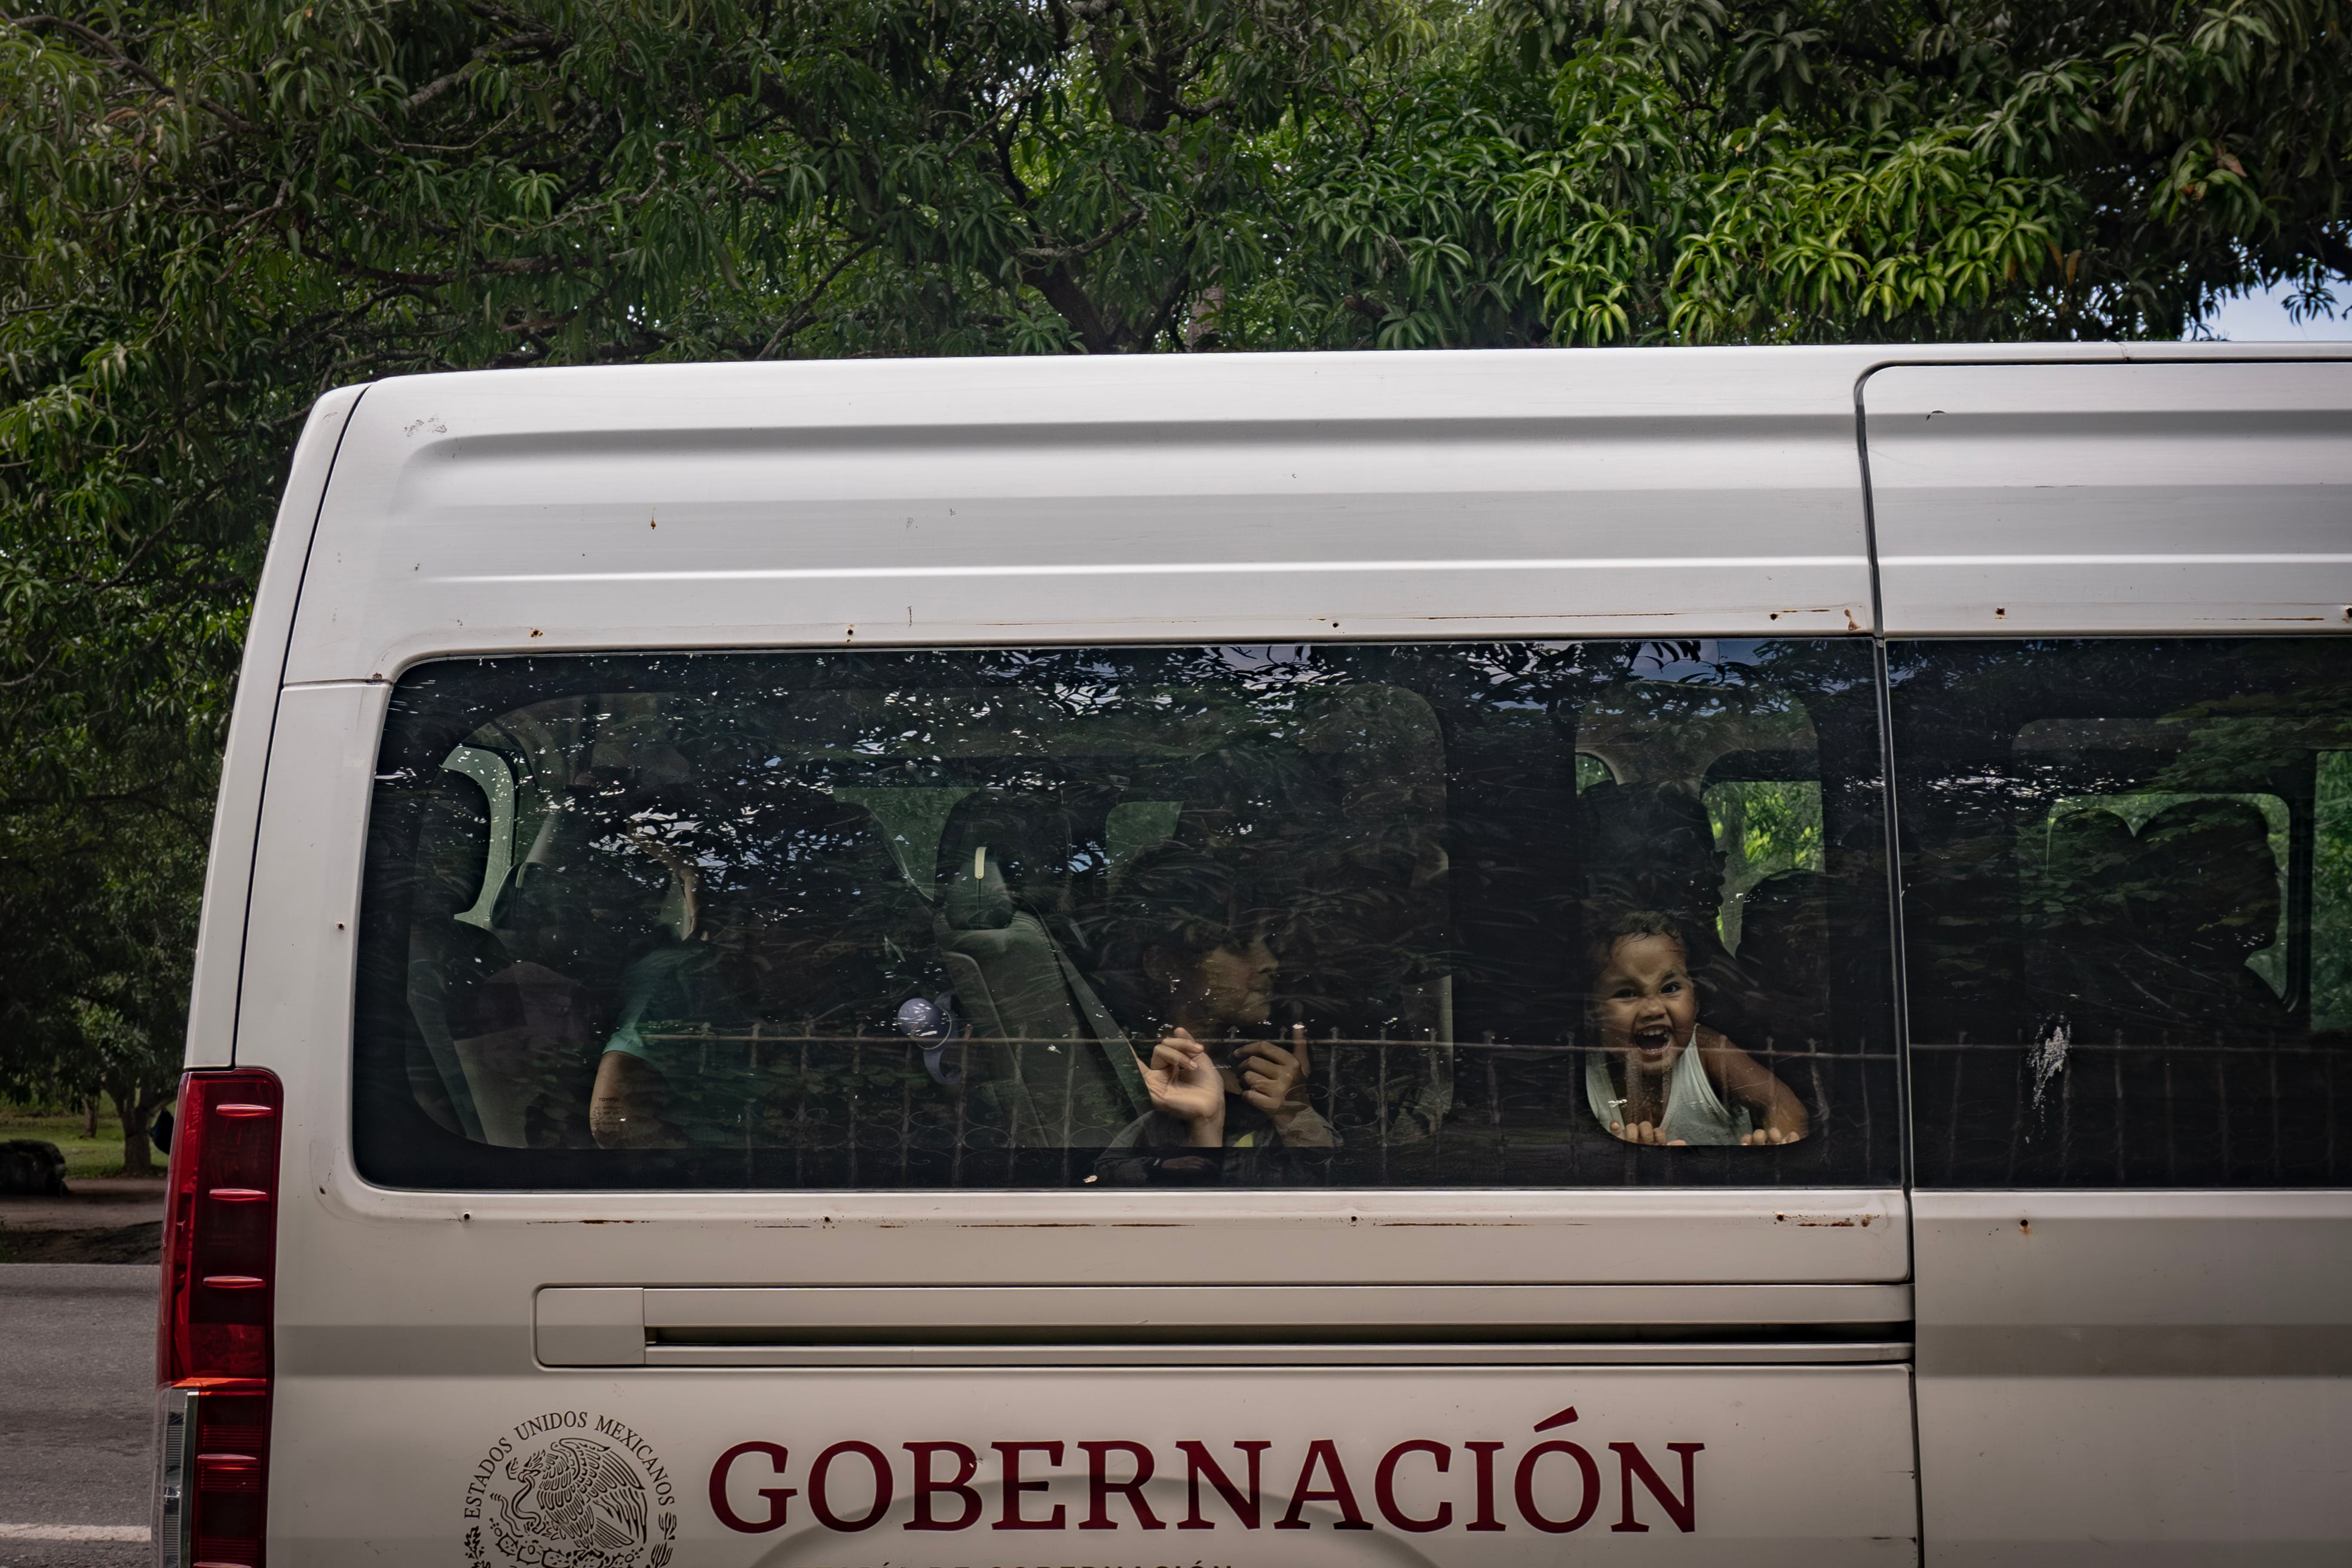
[186,385,367,1067]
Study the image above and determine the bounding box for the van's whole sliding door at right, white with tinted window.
[1865,365,2352,1566]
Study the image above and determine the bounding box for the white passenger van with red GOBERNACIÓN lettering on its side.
[158,345,2352,1568]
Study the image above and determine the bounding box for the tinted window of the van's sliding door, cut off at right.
[1893,639,2352,1187]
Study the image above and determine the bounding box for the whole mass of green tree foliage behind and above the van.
[0,0,2352,1166]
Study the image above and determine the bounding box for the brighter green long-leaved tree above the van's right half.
[1298,0,2352,345]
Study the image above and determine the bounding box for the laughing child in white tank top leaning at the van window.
[1585,909,1811,1145]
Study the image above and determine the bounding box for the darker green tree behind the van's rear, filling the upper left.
[0,0,1385,1163]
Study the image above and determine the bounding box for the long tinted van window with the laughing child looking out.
[357,642,1900,1190]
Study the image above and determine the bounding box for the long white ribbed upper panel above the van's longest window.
[289,350,1870,679]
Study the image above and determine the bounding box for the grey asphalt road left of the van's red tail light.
[0,1263,155,1568]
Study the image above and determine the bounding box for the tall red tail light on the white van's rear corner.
[155,1067,284,1568]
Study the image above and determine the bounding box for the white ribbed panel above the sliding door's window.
[1863,360,2352,635]
